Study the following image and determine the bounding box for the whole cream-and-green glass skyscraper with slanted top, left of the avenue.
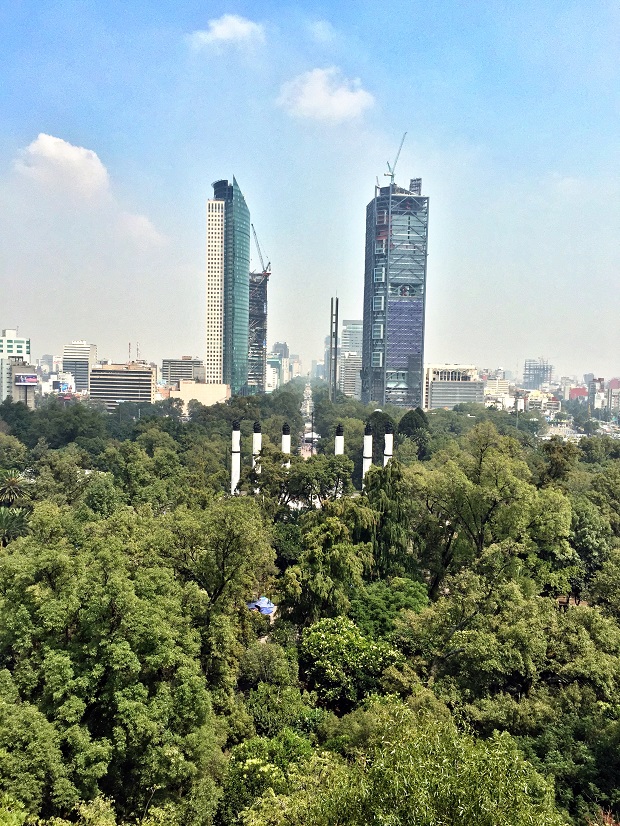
[205,178,250,393]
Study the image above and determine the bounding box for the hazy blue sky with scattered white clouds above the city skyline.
[0,0,620,377]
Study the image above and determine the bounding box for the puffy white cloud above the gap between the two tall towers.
[277,66,375,123]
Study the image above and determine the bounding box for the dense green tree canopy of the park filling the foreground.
[0,383,620,826]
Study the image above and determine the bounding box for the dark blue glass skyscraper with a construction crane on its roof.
[362,178,428,407]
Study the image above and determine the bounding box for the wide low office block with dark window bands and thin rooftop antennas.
[90,361,157,413]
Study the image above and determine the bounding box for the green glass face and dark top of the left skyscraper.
[213,177,250,393]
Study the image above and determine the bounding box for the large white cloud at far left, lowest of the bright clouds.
[15,133,110,198]
